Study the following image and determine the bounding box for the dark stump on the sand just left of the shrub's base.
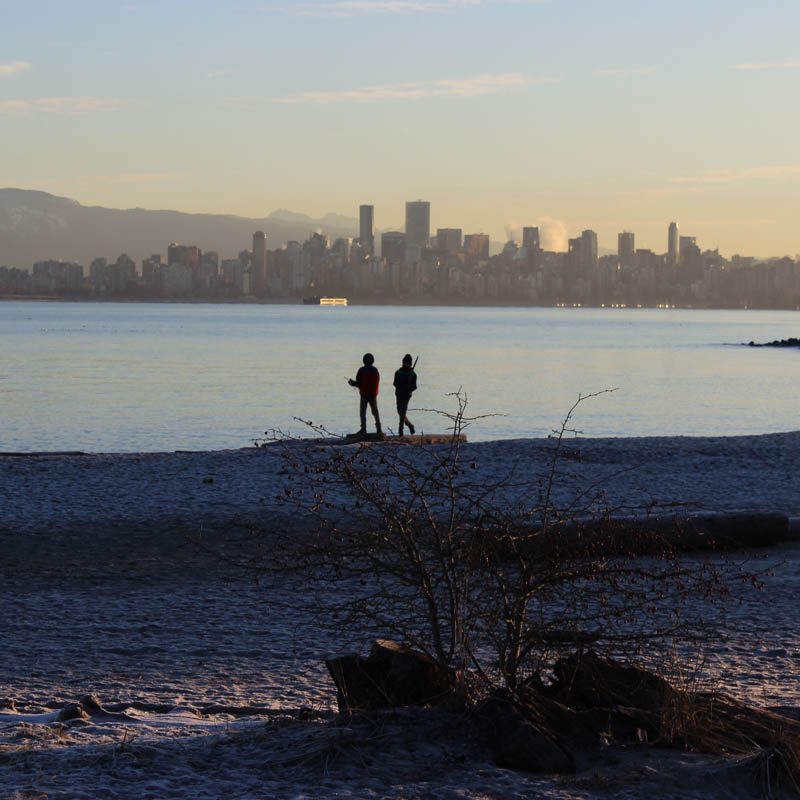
[325,640,452,711]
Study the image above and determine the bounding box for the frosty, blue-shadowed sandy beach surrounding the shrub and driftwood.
[0,432,800,800]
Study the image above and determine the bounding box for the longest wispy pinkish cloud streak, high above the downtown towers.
[274,72,555,103]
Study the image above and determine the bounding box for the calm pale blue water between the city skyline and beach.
[0,302,800,452]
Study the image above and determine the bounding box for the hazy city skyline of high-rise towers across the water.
[7,200,800,309]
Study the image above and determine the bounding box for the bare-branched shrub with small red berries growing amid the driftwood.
[248,391,755,693]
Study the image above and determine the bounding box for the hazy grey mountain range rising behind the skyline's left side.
[0,189,358,269]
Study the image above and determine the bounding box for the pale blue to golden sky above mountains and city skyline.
[0,0,800,257]
